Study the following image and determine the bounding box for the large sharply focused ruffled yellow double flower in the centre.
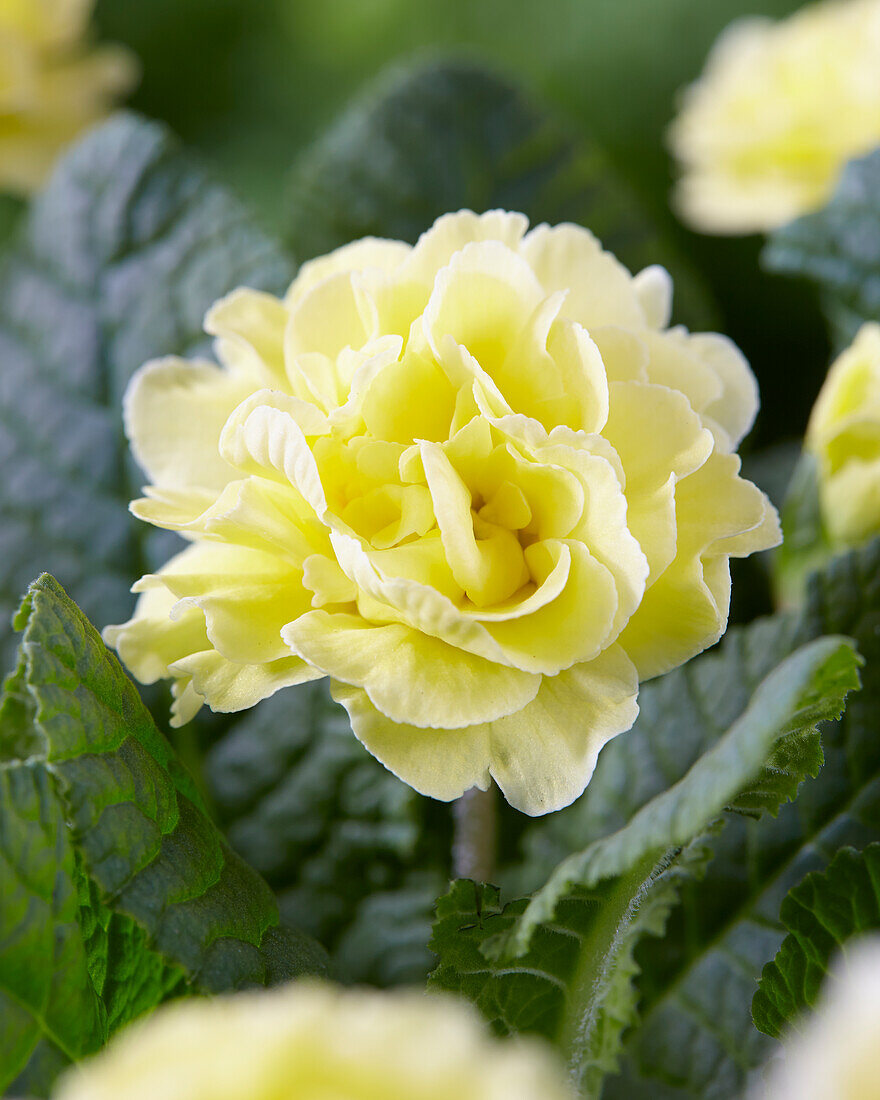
[105,211,779,814]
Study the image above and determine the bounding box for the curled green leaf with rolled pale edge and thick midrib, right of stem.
[431,637,858,1096]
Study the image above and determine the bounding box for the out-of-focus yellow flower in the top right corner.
[670,0,880,233]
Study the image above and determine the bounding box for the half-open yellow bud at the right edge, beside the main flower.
[805,323,880,546]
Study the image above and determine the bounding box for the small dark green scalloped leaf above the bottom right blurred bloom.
[751,844,880,1038]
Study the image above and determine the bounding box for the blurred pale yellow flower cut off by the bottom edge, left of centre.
[55,982,573,1100]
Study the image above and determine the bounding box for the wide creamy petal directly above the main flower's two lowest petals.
[283,611,541,729]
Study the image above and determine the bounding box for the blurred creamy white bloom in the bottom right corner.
[754,936,880,1100]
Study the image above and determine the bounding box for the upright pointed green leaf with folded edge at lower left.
[0,575,323,1095]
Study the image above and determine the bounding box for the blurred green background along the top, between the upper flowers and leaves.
[97,0,828,447]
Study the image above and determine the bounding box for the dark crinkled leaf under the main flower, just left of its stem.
[205,681,450,986]
